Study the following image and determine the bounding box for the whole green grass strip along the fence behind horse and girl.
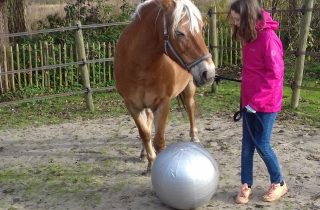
[0,63,320,129]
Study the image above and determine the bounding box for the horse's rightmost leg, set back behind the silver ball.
[181,81,200,143]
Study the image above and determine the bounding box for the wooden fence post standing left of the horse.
[75,21,94,111]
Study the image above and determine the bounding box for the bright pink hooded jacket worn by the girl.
[241,10,284,112]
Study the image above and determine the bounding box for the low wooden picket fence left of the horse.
[0,42,115,93]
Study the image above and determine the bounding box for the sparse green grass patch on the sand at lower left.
[0,163,105,205]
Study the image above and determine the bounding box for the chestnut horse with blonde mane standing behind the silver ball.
[114,0,215,174]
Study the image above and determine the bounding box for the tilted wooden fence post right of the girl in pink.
[291,0,313,109]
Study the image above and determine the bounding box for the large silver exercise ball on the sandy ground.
[151,142,219,209]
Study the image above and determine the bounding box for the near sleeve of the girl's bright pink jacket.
[248,34,284,110]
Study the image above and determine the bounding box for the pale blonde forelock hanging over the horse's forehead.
[172,0,202,33]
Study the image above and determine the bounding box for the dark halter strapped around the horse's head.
[163,15,212,71]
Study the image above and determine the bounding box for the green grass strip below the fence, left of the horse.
[0,89,126,129]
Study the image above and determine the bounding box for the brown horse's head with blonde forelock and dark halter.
[162,0,215,86]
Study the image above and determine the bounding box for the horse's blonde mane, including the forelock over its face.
[133,0,202,33]
